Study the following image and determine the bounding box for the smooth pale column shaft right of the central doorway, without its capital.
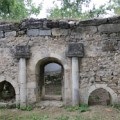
[72,57,80,106]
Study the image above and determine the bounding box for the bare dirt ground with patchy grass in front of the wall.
[0,106,120,120]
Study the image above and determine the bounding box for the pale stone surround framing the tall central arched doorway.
[29,51,71,105]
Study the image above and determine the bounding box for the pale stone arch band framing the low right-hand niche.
[86,84,118,104]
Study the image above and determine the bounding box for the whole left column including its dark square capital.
[15,46,30,107]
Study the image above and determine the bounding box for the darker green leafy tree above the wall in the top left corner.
[0,0,41,20]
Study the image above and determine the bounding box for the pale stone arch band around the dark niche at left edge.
[0,76,19,104]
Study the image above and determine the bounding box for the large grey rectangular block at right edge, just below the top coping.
[98,24,120,33]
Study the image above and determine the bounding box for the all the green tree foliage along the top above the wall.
[0,0,120,21]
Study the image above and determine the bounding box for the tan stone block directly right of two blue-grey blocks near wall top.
[52,28,69,36]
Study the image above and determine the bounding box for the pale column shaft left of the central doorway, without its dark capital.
[18,58,27,106]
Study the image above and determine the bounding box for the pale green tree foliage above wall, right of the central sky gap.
[48,0,107,19]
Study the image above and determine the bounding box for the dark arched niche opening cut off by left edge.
[0,81,15,102]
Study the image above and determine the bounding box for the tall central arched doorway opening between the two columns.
[36,57,64,100]
